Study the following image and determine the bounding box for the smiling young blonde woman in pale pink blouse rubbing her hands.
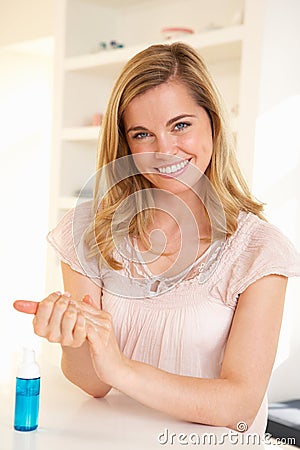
[15,43,300,433]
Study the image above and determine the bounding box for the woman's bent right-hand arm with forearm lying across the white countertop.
[87,275,287,429]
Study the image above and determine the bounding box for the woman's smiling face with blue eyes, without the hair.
[124,81,213,194]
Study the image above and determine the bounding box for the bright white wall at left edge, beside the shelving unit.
[0,39,52,381]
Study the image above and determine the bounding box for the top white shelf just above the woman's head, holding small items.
[65,25,244,71]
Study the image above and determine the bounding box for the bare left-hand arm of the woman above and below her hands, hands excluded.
[61,262,111,397]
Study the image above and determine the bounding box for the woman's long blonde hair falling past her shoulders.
[87,42,266,269]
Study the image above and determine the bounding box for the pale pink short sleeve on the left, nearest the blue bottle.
[47,201,102,285]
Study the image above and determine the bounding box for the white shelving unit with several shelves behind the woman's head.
[47,0,260,289]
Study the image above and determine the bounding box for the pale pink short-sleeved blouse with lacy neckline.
[48,202,300,434]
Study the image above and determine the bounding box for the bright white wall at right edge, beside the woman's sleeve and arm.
[253,0,300,401]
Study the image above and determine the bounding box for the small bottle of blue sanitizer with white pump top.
[14,349,40,431]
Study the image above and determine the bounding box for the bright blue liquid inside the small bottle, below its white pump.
[14,378,40,431]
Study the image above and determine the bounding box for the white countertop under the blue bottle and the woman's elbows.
[0,365,278,450]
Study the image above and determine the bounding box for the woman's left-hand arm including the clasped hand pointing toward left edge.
[14,264,111,397]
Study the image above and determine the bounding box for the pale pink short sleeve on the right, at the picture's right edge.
[225,221,300,306]
